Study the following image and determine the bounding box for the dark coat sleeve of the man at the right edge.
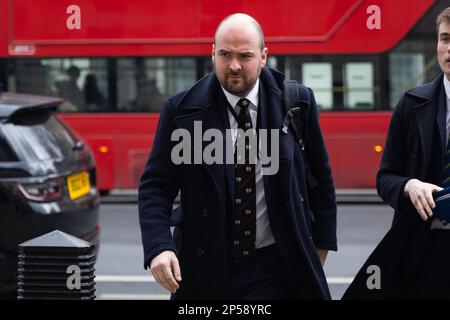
[377,96,411,210]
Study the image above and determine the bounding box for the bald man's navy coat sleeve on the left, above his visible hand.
[138,101,179,268]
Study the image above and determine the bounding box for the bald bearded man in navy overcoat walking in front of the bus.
[139,14,337,299]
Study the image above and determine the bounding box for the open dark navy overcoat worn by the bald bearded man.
[139,68,337,299]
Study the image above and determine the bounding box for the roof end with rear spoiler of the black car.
[0,92,63,122]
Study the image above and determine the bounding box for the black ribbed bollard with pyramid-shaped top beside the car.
[17,230,95,300]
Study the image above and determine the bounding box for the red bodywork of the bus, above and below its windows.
[0,0,434,190]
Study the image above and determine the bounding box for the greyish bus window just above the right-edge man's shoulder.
[389,53,425,108]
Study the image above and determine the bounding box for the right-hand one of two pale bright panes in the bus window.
[344,62,374,109]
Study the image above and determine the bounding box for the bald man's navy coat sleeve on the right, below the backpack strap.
[305,88,337,251]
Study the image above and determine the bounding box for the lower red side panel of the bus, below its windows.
[62,112,391,190]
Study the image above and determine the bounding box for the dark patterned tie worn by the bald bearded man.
[232,99,256,263]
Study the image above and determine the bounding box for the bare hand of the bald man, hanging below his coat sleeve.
[150,250,181,293]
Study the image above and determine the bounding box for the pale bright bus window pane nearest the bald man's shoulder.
[302,62,333,110]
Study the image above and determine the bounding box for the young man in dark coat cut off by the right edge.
[343,7,450,299]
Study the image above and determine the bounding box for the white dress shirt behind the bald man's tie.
[222,79,275,249]
